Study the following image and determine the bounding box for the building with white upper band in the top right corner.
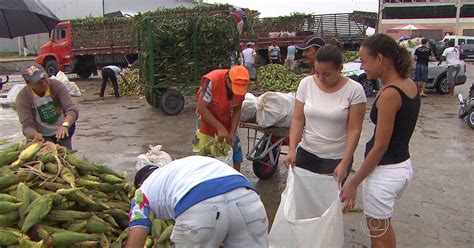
[378,0,474,40]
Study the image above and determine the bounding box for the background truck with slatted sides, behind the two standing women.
[250,11,377,65]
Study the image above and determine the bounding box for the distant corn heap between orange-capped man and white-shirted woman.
[257,64,301,92]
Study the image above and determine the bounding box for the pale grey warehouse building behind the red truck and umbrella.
[0,0,197,54]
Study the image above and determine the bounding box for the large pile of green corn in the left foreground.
[0,142,173,248]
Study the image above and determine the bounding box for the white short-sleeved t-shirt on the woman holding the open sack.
[296,76,367,159]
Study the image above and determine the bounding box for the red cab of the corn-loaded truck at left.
[36,21,74,76]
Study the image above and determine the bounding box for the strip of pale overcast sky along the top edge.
[203,0,378,17]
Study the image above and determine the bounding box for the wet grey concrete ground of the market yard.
[0,65,474,247]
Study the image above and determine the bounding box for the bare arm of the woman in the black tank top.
[340,88,402,209]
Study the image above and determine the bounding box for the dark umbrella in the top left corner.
[0,0,59,39]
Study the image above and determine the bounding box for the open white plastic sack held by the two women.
[268,167,344,248]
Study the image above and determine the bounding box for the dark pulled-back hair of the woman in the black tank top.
[361,34,412,78]
